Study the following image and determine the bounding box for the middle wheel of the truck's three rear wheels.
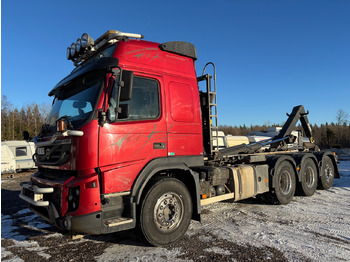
[297,158,318,196]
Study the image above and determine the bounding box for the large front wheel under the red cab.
[139,178,192,246]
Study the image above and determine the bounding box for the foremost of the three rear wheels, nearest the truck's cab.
[266,161,296,205]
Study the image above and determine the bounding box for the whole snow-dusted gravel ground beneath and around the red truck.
[1,159,350,261]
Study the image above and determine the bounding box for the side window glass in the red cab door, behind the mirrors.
[111,76,160,121]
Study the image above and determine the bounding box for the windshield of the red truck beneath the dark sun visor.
[46,74,105,128]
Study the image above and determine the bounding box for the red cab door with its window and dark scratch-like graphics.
[98,72,167,194]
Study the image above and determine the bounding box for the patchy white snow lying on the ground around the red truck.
[1,160,350,261]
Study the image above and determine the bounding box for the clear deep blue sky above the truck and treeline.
[1,0,350,125]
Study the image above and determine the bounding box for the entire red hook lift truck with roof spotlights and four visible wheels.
[20,30,339,246]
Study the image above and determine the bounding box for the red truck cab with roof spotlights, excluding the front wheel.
[20,31,203,242]
